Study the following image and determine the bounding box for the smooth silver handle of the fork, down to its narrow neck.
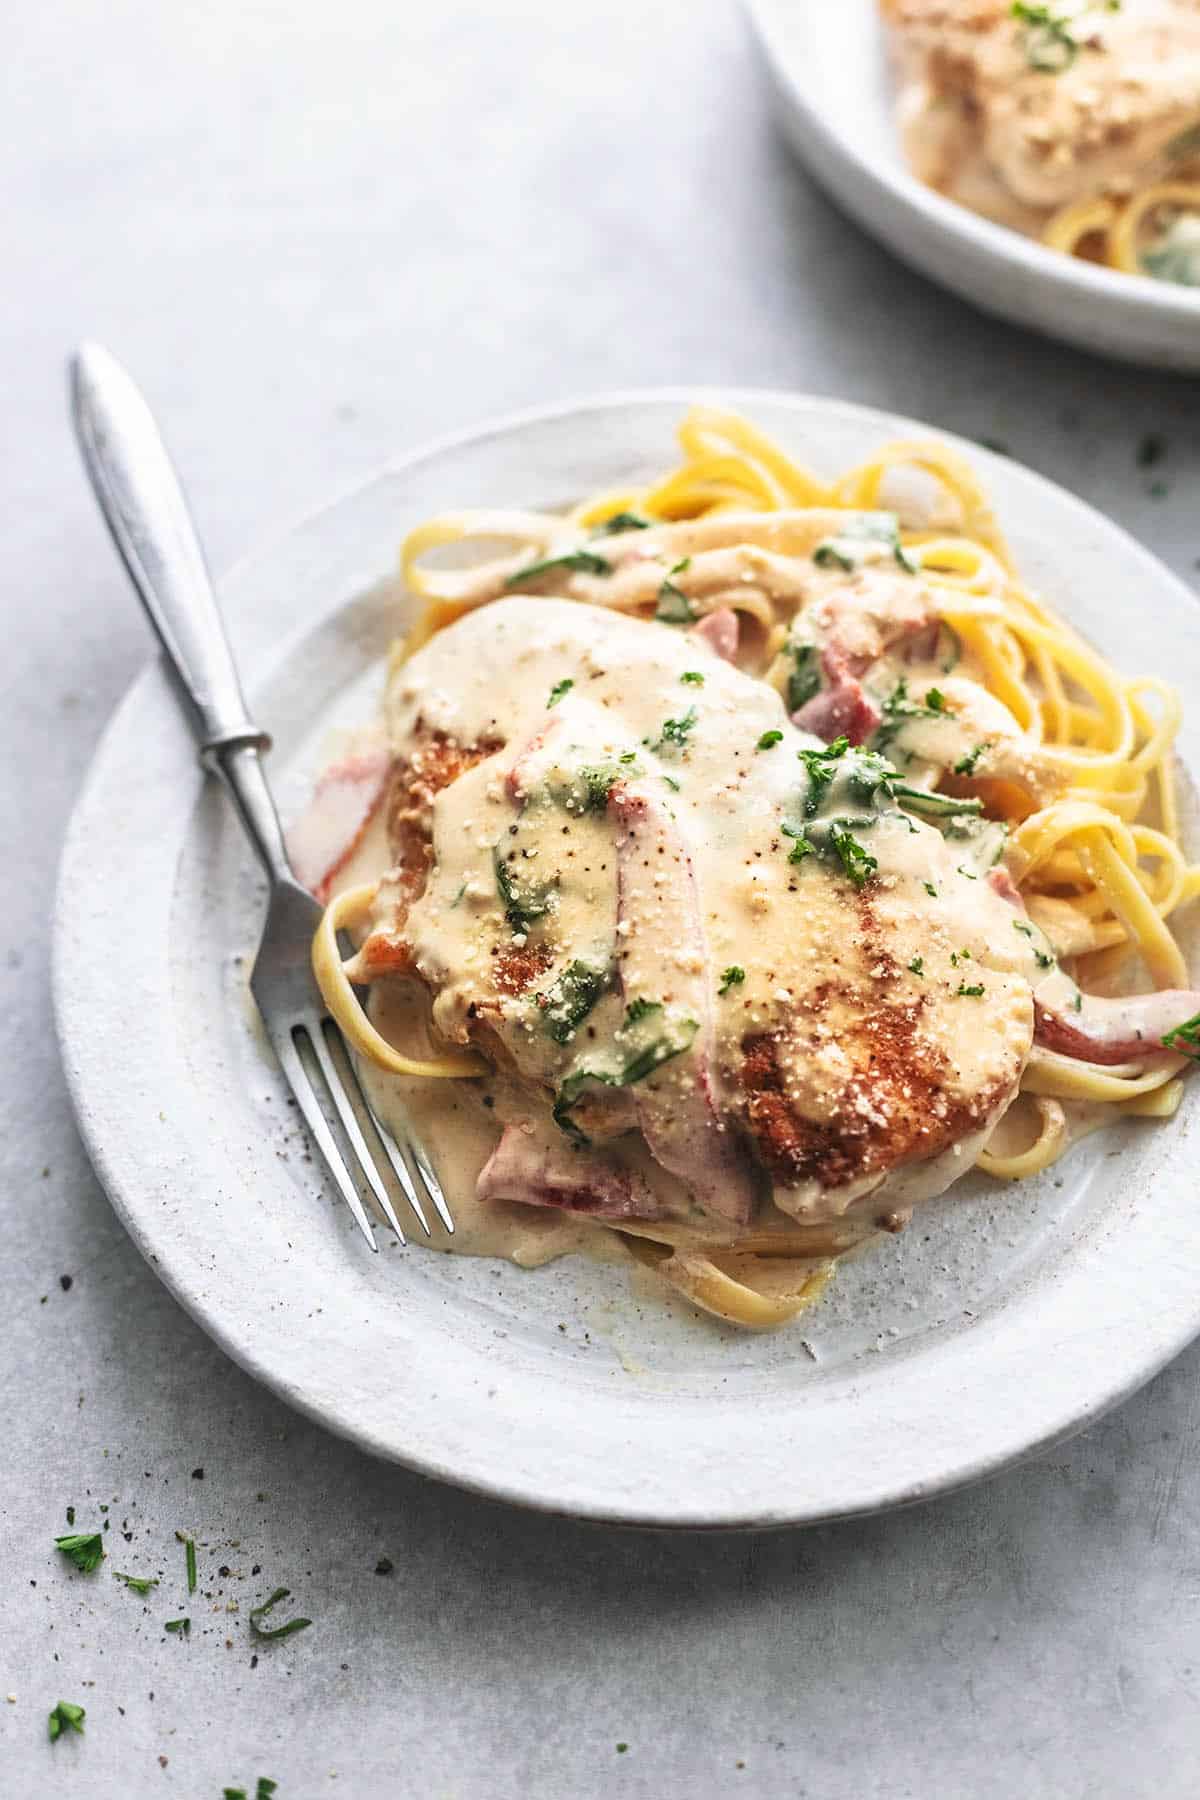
[70,344,295,882]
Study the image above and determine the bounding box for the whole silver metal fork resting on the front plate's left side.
[70,344,453,1249]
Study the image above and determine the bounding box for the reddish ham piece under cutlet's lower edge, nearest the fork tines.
[475,1123,664,1219]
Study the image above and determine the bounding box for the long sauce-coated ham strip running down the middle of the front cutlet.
[608,783,756,1224]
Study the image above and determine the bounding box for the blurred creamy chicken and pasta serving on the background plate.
[882,0,1200,281]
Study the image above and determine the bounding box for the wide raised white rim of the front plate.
[54,389,1200,1530]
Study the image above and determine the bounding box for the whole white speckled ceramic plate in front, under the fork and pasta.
[56,392,1200,1526]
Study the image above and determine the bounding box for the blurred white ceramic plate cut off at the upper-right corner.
[745,0,1200,371]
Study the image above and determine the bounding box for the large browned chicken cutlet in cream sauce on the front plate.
[360,597,1036,1240]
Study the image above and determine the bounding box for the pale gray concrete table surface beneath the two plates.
[0,0,1200,1800]
